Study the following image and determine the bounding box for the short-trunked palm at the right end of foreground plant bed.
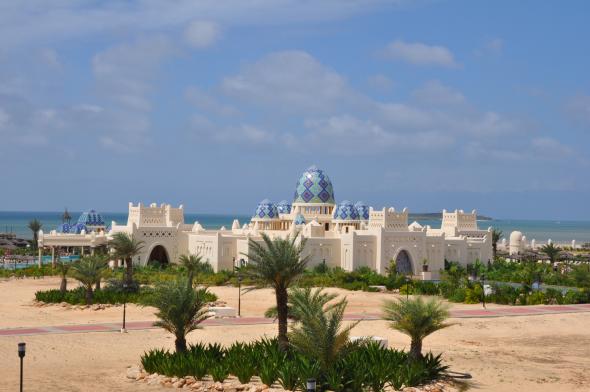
[383,297,453,360]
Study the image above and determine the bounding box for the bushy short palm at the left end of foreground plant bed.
[142,279,209,352]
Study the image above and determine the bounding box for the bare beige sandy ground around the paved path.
[0,278,590,392]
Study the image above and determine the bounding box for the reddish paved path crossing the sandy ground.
[0,304,590,337]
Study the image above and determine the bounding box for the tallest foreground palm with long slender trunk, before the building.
[244,233,309,350]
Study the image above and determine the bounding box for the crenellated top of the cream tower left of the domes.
[127,203,184,227]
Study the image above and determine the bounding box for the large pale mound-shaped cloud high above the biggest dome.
[221,51,354,111]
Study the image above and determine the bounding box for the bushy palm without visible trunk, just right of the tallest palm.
[289,289,360,372]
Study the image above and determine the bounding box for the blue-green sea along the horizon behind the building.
[0,211,590,244]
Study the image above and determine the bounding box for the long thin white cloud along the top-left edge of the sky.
[0,0,405,48]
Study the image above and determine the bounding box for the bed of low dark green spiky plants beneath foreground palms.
[141,339,447,391]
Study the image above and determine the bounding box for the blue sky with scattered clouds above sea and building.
[0,0,590,220]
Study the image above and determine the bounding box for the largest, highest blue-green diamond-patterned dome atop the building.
[293,166,336,204]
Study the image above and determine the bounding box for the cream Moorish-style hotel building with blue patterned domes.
[39,166,492,279]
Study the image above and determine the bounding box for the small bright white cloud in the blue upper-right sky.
[382,40,459,68]
